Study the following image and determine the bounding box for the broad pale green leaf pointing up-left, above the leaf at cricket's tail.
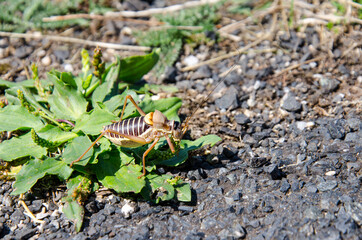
[48,74,88,120]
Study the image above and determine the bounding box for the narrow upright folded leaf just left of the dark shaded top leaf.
[92,58,121,107]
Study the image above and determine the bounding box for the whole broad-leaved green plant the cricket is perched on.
[0,48,220,231]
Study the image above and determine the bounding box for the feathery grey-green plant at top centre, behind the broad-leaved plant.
[135,4,220,75]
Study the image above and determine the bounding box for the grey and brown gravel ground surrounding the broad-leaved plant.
[0,0,362,240]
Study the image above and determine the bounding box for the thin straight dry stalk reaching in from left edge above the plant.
[0,32,151,52]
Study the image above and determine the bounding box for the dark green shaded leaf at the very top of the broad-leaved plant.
[119,49,160,83]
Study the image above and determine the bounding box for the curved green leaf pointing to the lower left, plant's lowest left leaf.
[11,158,73,195]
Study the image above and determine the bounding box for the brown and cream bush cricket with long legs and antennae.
[70,65,235,178]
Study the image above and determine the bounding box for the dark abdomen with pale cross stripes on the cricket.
[104,117,151,138]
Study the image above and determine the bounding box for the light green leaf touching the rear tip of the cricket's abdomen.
[73,108,118,135]
